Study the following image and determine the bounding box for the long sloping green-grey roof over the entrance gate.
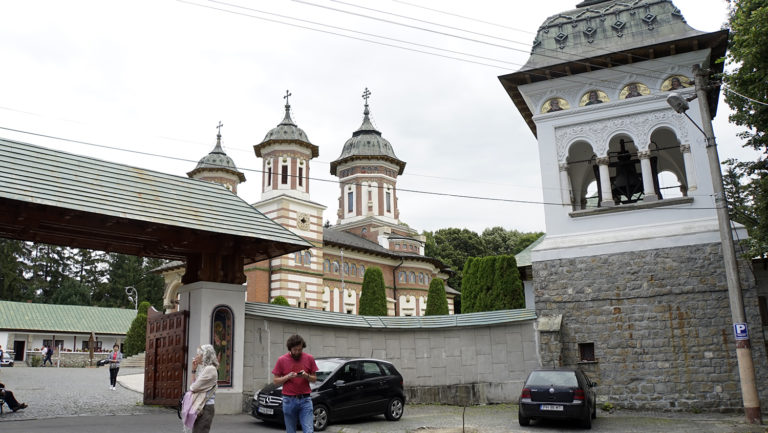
[0,139,311,262]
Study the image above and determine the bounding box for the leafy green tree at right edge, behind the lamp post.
[724,0,768,257]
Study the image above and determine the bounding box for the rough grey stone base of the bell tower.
[533,244,768,411]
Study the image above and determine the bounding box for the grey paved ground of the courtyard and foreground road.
[0,367,768,433]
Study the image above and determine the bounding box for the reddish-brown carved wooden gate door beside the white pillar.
[144,307,189,406]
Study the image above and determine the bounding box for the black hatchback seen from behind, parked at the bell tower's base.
[517,368,597,429]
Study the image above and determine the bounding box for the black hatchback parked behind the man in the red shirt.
[251,358,405,431]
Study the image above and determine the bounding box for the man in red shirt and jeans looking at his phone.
[272,334,317,433]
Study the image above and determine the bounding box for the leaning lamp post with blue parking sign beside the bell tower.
[667,65,762,424]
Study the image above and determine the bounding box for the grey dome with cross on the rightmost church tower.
[331,94,405,176]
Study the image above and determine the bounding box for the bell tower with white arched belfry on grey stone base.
[499,0,768,410]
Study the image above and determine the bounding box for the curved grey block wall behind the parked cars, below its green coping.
[243,315,539,410]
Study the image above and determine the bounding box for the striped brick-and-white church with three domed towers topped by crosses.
[178,89,458,316]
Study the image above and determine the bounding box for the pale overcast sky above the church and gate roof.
[0,0,752,232]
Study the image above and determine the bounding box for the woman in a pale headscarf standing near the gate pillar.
[181,344,219,433]
